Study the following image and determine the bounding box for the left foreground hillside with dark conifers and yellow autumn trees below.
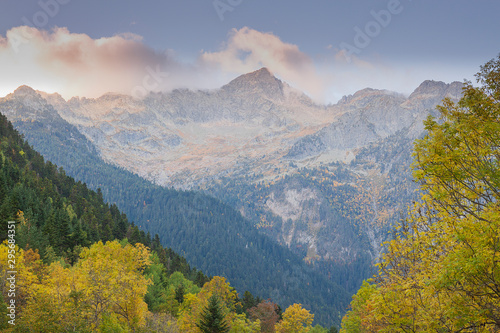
[0,110,346,333]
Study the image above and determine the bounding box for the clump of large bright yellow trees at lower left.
[0,241,150,332]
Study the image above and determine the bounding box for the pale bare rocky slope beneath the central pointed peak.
[44,68,339,189]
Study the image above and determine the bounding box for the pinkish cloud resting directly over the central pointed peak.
[200,27,325,99]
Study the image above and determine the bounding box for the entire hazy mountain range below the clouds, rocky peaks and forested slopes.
[0,68,462,322]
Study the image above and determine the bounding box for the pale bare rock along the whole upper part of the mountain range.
[4,73,462,184]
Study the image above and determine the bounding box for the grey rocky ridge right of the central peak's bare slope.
[286,81,462,160]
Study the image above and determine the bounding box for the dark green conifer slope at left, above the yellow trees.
[0,110,208,284]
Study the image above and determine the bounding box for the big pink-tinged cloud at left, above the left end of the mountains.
[0,26,194,98]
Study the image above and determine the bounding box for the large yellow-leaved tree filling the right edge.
[343,56,500,332]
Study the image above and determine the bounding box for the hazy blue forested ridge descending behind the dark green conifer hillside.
[0,87,349,325]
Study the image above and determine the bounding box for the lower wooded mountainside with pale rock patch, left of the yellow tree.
[208,128,416,293]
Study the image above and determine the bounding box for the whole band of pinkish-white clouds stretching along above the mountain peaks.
[0,26,475,102]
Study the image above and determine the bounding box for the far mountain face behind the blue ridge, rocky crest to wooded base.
[37,68,462,272]
